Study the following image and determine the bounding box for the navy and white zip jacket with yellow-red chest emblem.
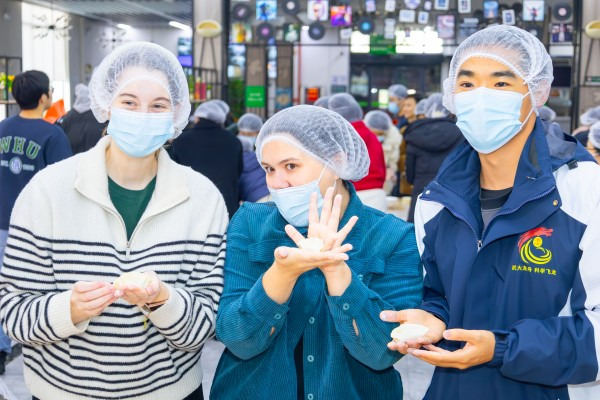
[415,119,600,400]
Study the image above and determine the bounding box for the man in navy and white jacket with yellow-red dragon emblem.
[381,26,600,400]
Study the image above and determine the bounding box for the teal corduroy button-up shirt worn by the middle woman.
[210,185,423,400]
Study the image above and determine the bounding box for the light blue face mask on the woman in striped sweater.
[106,108,175,158]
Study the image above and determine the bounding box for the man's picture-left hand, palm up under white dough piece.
[380,309,446,354]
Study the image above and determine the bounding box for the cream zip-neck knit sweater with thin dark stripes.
[0,138,227,400]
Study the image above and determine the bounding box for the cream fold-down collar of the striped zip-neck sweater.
[74,136,190,219]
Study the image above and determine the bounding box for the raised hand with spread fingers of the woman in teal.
[285,187,358,272]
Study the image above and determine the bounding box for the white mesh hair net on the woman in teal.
[256,105,370,181]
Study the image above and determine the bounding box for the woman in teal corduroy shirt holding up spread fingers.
[210,106,422,400]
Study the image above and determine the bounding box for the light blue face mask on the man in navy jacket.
[454,87,533,154]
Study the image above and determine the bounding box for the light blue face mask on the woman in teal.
[269,166,337,228]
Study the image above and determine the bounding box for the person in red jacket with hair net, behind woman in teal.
[329,93,387,212]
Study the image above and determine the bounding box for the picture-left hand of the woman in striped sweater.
[71,281,118,325]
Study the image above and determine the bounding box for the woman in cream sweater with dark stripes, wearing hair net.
[0,43,227,400]
